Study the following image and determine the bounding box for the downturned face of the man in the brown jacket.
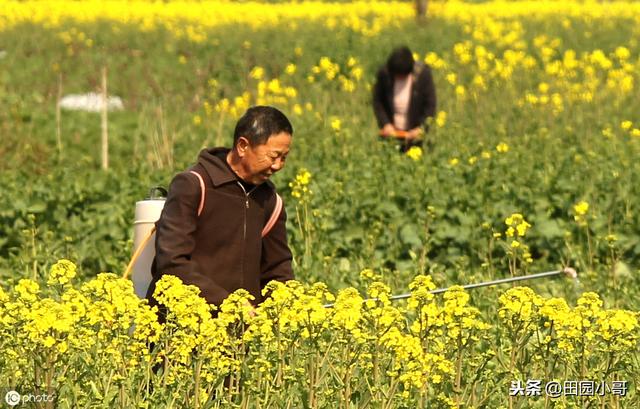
[237,132,291,185]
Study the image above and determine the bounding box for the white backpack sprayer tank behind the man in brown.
[131,198,165,298]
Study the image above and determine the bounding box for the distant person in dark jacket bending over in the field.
[373,47,436,152]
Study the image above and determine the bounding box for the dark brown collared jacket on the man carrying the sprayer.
[147,148,293,305]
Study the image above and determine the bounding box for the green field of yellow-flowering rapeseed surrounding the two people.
[0,0,640,409]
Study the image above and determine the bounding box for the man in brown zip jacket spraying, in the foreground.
[147,106,293,306]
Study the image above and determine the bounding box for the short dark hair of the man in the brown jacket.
[233,105,293,146]
